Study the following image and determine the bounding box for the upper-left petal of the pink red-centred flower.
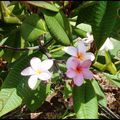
[66,57,78,69]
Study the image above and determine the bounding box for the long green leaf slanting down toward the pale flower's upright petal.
[43,11,70,45]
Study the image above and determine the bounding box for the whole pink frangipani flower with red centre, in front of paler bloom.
[66,57,93,86]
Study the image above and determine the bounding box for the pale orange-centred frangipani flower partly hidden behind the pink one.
[64,41,95,61]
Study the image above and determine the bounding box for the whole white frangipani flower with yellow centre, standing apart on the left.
[21,57,53,89]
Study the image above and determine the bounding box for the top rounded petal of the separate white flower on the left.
[30,57,41,70]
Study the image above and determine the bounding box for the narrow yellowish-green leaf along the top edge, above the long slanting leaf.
[27,1,59,12]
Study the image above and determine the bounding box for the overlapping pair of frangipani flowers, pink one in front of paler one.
[64,41,95,86]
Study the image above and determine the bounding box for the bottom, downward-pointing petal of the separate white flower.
[28,75,40,90]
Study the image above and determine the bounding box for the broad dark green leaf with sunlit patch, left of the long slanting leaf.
[21,14,47,42]
